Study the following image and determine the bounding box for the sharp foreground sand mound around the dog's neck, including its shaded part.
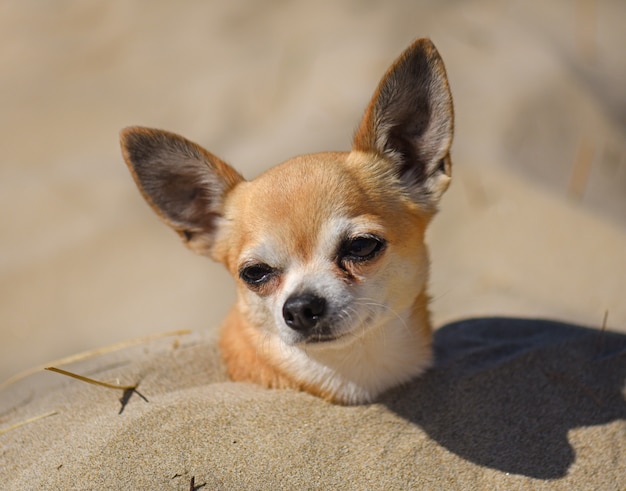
[0,318,626,490]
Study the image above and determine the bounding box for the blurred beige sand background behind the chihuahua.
[0,0,626,380]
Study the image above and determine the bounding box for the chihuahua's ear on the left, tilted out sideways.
[120,127,244,254]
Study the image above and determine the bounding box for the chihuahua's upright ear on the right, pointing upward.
[353,39,454,210]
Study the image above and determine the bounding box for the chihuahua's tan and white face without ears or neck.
[214,153,429,349]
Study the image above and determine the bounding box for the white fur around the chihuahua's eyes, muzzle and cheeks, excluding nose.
[240,209,427,350]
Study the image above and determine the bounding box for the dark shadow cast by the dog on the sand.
[381,318,626,479]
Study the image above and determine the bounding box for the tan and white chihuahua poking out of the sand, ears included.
[120,39,454,404]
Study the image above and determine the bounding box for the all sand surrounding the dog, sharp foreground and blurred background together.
[0,0,626,489]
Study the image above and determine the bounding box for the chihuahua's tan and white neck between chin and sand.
[221,291,431,404]
